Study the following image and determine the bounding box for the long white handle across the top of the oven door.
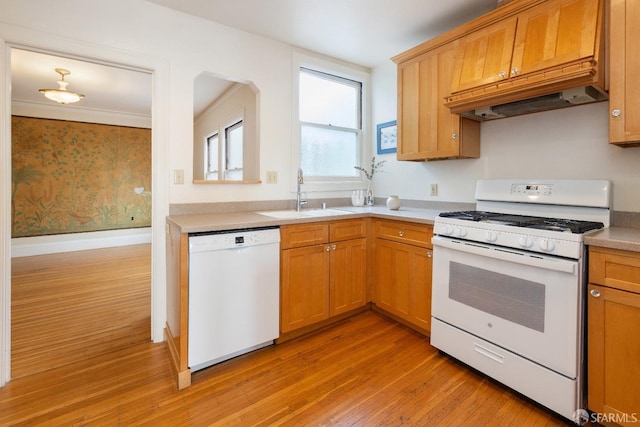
[432,236,578,274]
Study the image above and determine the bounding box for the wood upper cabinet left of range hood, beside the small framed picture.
[397,42,480,161]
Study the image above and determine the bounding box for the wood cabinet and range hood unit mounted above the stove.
[444,0,608,120]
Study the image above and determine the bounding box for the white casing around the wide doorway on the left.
[0,27,171,386]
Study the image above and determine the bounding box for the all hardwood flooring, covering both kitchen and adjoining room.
[0,248,573,426]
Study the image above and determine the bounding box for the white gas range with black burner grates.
[431,179,611,422]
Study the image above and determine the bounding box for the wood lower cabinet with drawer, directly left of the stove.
[373,220,433,334]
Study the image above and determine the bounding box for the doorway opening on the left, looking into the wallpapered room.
[10,47,153,378]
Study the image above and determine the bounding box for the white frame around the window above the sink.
[291,51,372,192]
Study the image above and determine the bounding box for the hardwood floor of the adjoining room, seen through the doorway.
[11,244,151,378]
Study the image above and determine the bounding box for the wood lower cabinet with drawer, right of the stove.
[587,247,640,426]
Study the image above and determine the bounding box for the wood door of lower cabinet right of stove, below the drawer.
[587,284,640,425]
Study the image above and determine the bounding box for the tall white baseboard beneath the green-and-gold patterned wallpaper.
[11,228,151,258]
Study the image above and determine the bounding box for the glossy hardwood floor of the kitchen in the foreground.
[0,246,572,426]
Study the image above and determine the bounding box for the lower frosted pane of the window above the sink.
[300,124,359,177]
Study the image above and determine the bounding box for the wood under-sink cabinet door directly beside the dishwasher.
[280,245,330,332]
